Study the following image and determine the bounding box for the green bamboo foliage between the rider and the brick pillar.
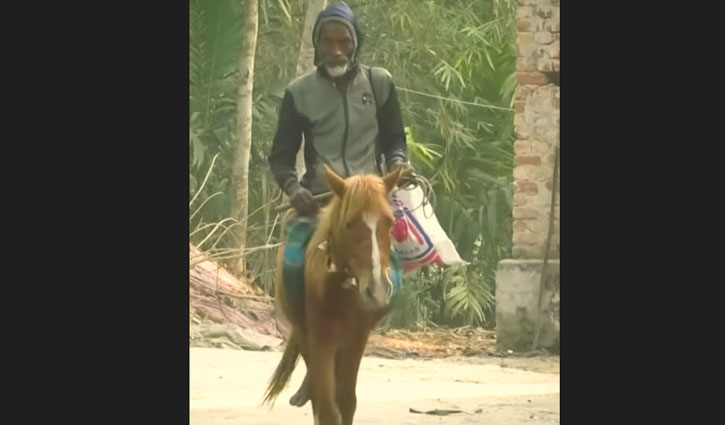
[351,0,516,326]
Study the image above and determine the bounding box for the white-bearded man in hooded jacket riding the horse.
[269,3,413,418]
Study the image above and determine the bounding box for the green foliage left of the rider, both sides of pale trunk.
[189,0,304,280]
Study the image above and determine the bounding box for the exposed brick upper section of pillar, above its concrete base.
[513,0,561,259]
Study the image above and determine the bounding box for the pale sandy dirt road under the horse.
[190,347,559,425]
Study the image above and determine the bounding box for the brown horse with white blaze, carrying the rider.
[264,168,401,425]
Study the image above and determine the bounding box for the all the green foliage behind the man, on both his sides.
[189,0,517,326]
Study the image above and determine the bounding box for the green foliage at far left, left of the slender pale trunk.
[189,0,243,225]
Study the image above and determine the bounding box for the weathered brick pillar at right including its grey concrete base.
[496,0,561,351]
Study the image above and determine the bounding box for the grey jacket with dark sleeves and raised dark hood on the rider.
[269,3,408,194]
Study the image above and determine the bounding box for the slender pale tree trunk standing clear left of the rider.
[232,0,258,273]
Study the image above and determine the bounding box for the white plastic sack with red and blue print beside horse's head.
[391,186,467,273]
